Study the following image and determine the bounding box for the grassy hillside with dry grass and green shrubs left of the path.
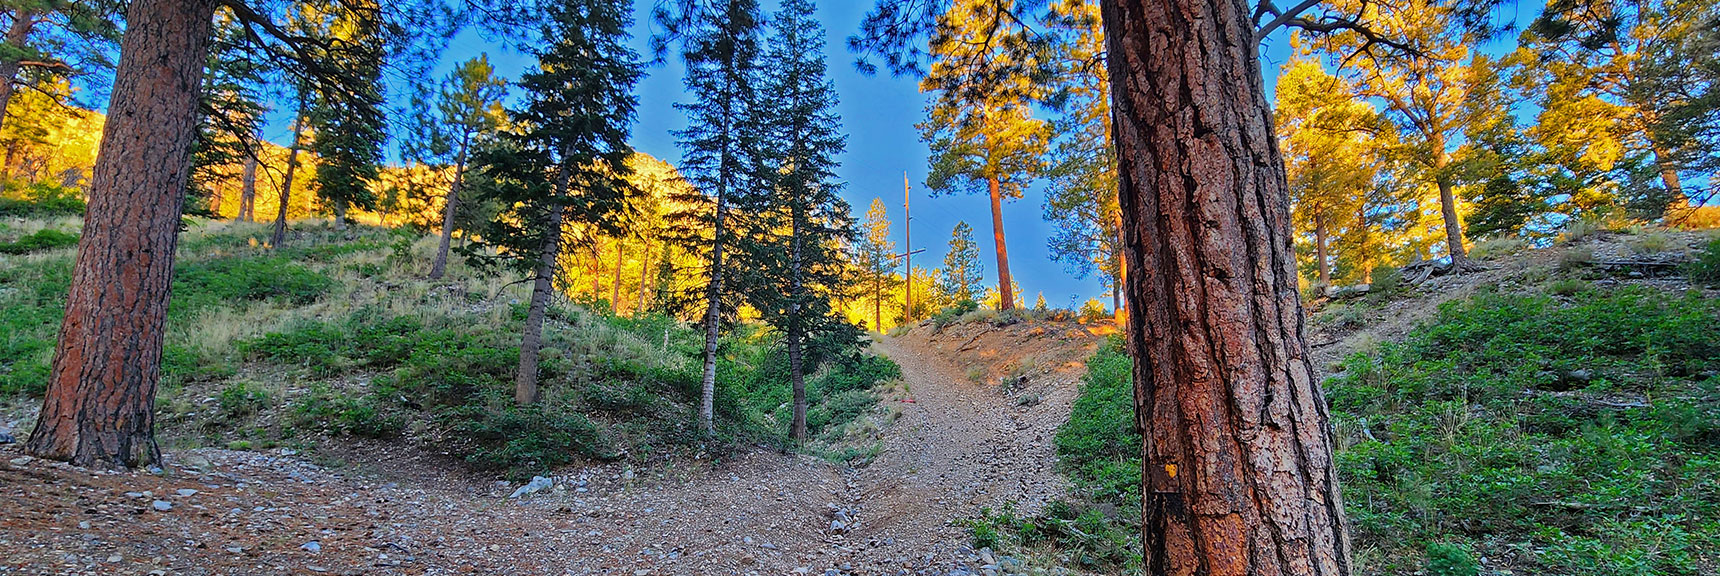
[0,218,898,476]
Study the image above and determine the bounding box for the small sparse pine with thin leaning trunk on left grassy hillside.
[409,55,507,280]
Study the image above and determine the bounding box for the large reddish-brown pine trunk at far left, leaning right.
[26,0,215,468]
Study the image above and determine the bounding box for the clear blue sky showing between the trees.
[278,0,1539,308]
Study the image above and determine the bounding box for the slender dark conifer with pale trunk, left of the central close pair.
[657,0,765,435]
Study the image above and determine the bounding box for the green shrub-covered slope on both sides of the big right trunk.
[975,235,1720,576]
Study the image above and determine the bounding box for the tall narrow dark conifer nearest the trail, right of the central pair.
[748,0,853,442]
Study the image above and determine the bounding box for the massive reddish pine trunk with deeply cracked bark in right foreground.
[1104,0,1350,576]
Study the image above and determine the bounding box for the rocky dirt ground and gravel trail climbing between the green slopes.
[0,322,1097,576]
